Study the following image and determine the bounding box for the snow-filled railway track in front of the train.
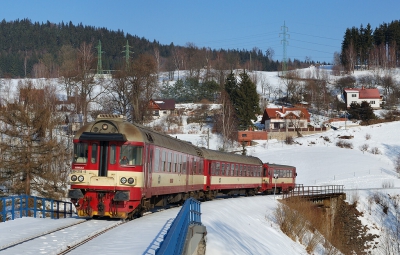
[0,219,125,255]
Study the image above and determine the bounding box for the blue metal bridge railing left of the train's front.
[0,195,72,222]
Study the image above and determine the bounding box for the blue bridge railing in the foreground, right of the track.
[156,198,201,255]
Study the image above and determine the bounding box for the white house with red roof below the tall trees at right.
[343,86,382,109]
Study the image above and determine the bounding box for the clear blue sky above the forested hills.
[0,0,400,62]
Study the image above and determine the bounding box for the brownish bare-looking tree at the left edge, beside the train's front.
[0,81,70,199]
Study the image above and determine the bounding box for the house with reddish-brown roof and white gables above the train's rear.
[261,107,310,131]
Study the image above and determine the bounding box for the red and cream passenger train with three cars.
[68,114,297,219]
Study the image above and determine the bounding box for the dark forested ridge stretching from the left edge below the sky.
[0,19,290,78]
